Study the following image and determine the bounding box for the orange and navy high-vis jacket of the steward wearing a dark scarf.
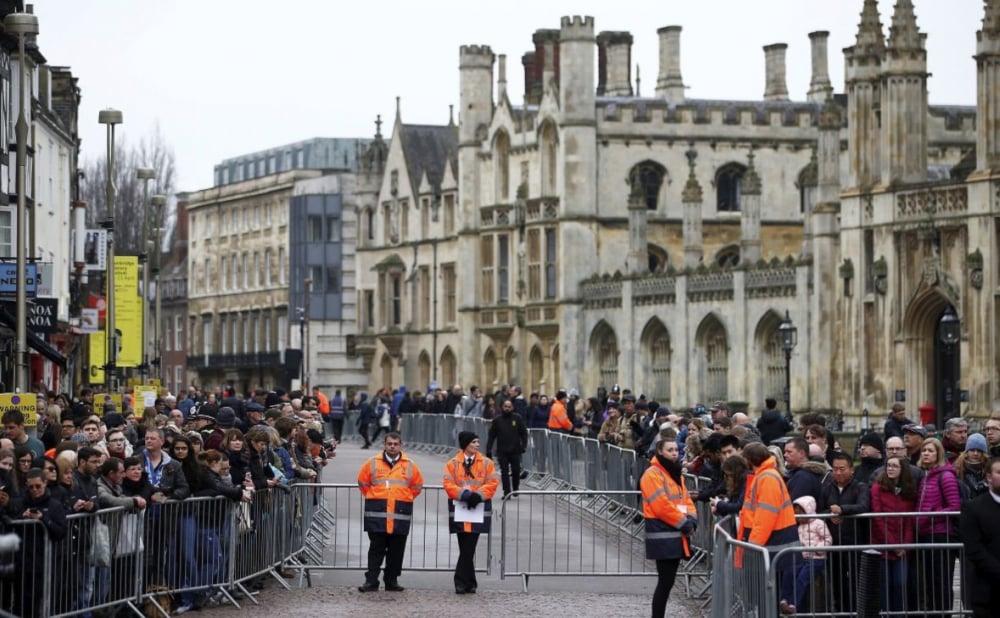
[639,457,697,560]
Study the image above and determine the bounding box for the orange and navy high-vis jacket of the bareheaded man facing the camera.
[358,454,424,535]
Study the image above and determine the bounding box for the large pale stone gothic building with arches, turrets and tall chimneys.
[358,0,1000,421]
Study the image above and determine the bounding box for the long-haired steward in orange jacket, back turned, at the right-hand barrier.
[736,443,799,566]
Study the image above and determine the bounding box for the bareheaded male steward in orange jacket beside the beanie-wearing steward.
[358,432,424,592]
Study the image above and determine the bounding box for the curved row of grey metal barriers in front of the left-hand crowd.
[0,484,322,618]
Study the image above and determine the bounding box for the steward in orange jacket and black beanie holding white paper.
[442,431,500,594]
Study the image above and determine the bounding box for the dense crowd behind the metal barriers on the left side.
[0,382,336,616]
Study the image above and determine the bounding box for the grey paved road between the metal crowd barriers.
[213,442,703,617]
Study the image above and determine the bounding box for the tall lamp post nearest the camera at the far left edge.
[3,13,38,393]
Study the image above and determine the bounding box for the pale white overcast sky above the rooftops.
[41,0,983,190]
